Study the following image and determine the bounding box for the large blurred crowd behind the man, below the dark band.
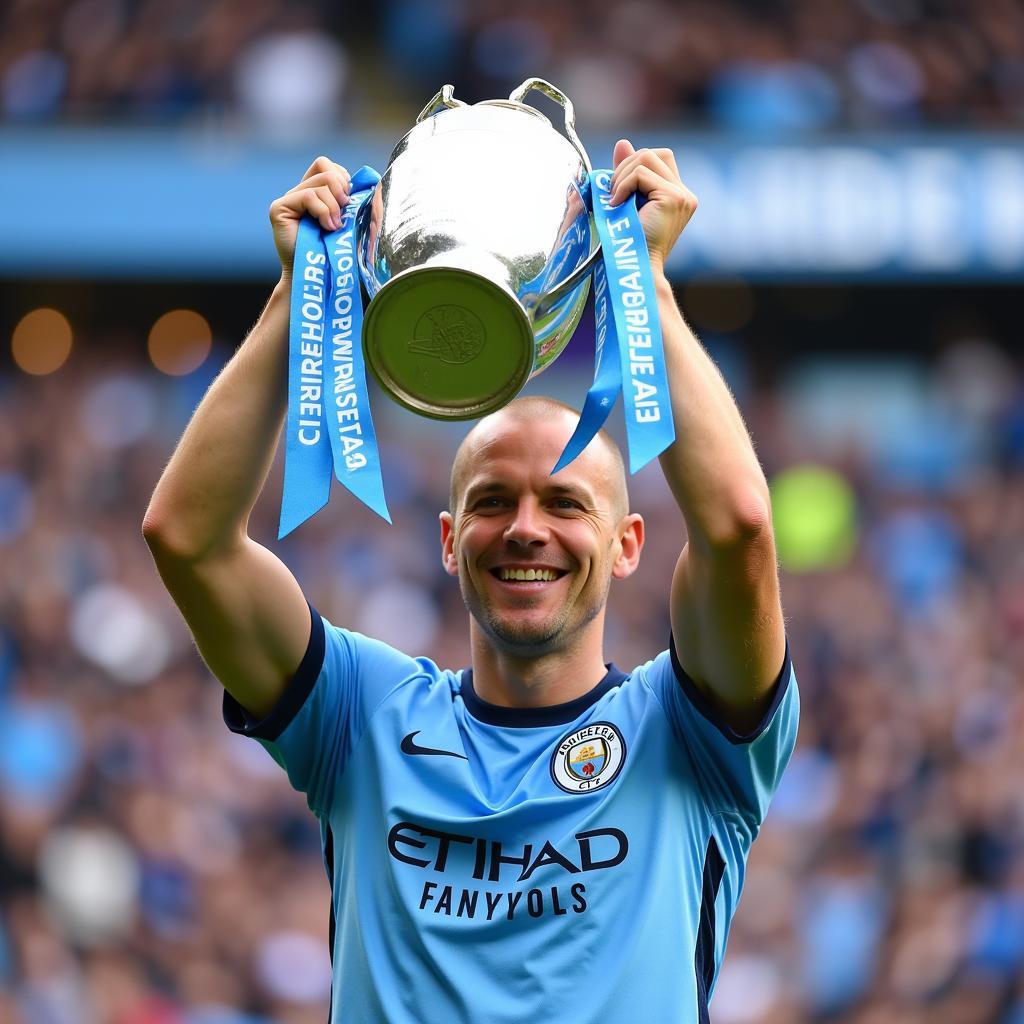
[0,307,1024,1024]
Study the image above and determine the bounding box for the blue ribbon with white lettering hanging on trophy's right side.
[552,170,676,474]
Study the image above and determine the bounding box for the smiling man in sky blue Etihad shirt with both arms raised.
[143,140,798,1024]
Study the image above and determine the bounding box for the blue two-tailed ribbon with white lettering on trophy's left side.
[278,167,391,540]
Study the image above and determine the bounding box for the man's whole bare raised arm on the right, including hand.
[612,140,785,732]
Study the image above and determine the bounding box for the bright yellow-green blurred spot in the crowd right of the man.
[771,465,857,572]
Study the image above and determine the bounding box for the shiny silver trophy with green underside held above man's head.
[356,78,600,420]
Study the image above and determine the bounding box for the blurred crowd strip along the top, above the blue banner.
[6,0,1024,133]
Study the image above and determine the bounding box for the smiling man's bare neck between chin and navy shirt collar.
[470,623,607,708]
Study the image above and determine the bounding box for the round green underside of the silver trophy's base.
[362,266,535,420]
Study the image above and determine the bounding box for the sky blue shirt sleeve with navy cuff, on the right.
[647,642,800,841]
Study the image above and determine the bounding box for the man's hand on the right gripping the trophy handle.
[611,138,697,270]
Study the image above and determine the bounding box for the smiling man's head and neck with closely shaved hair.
[441,398,643,707]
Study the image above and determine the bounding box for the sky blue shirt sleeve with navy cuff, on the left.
[224,605,420,814]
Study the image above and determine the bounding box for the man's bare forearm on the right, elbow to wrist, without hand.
[654,270,768,544]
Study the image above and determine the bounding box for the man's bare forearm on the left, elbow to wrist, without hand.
[143,281,289,558]
